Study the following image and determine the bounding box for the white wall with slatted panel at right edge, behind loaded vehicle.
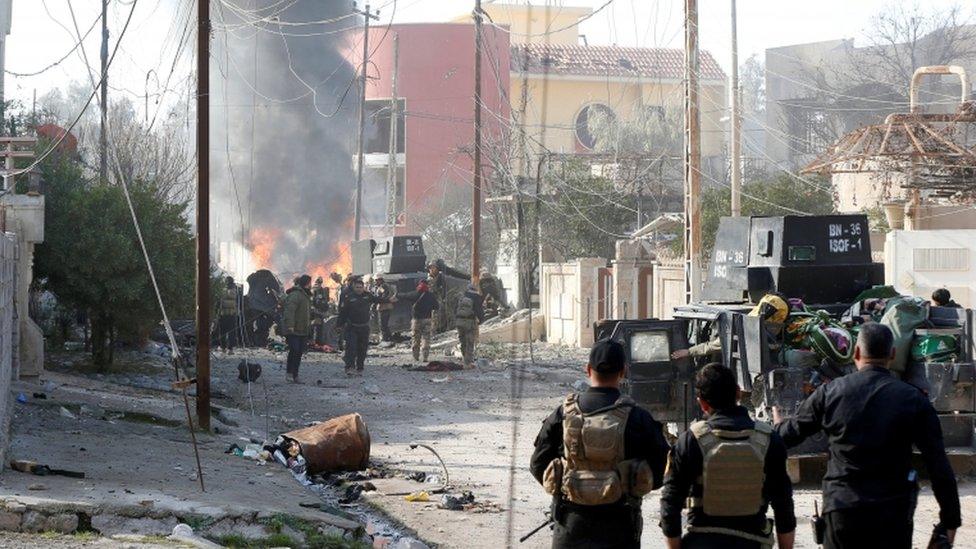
[885,229,976,307]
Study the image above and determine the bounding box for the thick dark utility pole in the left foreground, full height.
[195,0,210,431]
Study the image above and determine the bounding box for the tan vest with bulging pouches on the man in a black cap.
[543,393,653,505]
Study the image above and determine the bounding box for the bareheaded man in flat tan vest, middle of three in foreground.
[661,363,796,549]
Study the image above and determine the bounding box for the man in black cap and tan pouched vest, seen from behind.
[530,340,668,549]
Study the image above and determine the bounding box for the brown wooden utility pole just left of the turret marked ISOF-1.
[684,0,701,303]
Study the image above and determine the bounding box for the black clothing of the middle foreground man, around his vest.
[661,406,796,549]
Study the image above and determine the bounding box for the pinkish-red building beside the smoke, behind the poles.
[347,23,510,237]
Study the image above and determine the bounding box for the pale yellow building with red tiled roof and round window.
[458,4,727,166]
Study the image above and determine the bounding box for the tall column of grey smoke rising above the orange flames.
[210,0,361,274]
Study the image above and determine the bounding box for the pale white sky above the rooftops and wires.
[5,0,976,111]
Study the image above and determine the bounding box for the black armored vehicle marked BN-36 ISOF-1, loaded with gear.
[594,215,976,453]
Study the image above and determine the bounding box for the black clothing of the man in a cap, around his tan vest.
[529,387,668,549]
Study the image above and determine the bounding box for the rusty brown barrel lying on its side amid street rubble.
[282,414,369,475]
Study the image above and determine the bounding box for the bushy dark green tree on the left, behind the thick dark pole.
[36,150,194,365]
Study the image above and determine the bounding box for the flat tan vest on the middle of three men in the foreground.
[688,421,773,517]
